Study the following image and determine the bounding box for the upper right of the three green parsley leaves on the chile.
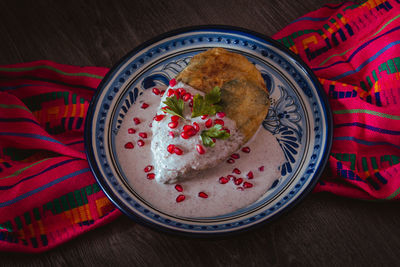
[192,86,222,118]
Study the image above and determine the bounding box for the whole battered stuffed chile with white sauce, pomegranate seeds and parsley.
[151,48,269,183]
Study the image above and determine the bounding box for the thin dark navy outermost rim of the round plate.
[84,24,333,238]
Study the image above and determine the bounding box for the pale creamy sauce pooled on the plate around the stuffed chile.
[116,85,284,217]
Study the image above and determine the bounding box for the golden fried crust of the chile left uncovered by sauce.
[176,48,270,142]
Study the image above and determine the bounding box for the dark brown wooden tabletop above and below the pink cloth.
[0,0,400,266]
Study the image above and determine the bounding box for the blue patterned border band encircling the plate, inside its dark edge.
[85,27,332,237]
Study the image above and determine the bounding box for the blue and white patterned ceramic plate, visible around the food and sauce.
[85,26,332,236]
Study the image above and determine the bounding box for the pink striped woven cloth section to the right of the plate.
[274,0,400,200]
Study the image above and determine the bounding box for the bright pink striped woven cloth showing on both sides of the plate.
[0,0,400,252]
